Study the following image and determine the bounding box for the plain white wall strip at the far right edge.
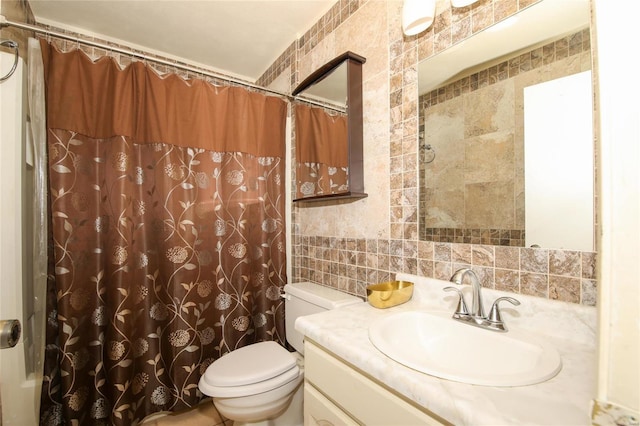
[594,0,640,415]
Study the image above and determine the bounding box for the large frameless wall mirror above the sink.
[418,0,595,251]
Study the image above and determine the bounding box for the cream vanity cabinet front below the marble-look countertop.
[304,340,447,426]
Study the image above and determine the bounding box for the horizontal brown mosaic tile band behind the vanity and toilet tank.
[296,236,597,306]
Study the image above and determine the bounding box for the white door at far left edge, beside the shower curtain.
[0,46,40,426]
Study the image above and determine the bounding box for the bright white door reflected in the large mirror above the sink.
[524,71,594,251]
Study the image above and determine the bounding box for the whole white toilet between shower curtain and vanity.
[198,282,362,426]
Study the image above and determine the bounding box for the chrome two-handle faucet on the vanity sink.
[444,268,520,331]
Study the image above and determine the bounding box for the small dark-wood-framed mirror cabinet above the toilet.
[293,52,367,202]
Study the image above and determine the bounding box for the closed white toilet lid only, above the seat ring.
[205,341,296,387]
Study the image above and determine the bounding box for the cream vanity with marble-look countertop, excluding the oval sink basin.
[296,274,596,426]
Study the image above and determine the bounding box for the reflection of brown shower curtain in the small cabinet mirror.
[295,104,349,198]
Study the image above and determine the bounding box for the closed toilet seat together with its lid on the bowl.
[199,341,300,398]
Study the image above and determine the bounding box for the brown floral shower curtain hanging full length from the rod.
[41,41,286,425]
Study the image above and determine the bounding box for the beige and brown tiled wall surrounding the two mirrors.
[259,0,596,305]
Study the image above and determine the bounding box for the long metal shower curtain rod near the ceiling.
[0,15,293,99]
